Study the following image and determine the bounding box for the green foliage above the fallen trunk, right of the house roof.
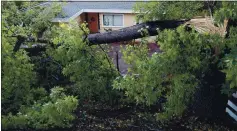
[134,1,204,21]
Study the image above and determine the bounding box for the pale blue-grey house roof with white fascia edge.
[52,1,136,22]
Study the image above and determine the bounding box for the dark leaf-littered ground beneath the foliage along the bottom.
[48,104,237,131]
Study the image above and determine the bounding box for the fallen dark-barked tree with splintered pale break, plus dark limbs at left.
[14,18,228,51]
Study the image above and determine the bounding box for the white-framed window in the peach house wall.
[103,14,123,26]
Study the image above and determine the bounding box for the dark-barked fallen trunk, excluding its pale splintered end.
[88,20,188,45]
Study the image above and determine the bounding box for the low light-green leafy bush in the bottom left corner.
[2,87,78,129]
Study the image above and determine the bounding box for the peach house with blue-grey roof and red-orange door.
[52,1,136,33]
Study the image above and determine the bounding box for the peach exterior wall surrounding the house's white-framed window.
[99,13,136,32]
